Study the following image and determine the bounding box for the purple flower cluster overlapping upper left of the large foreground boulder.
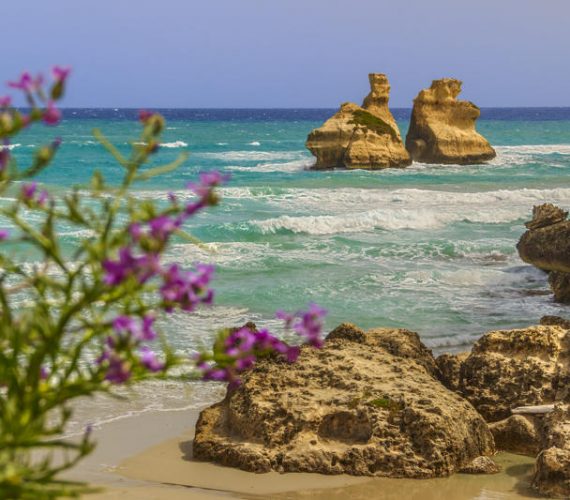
[195,304,327,387]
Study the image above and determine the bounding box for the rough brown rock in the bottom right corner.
[532,404,570,498]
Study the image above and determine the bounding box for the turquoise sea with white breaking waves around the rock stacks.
[7,108,570,432]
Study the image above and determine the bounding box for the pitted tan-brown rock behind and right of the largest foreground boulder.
[438,326,570,422]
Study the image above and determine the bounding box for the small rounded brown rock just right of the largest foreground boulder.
[489,415,542,457]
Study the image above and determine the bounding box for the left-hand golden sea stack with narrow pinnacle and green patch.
[306,73,411,169]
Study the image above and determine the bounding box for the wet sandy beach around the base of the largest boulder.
[71,409,537,500]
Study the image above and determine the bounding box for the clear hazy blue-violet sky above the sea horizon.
[4,0,570,108]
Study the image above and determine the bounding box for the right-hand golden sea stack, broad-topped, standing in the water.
[406,78,496,165]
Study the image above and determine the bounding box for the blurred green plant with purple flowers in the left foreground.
[0,67,324,498]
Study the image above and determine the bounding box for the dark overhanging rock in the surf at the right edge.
[517,203,570,303]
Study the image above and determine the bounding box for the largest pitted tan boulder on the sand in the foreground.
[194,324,494,478]
